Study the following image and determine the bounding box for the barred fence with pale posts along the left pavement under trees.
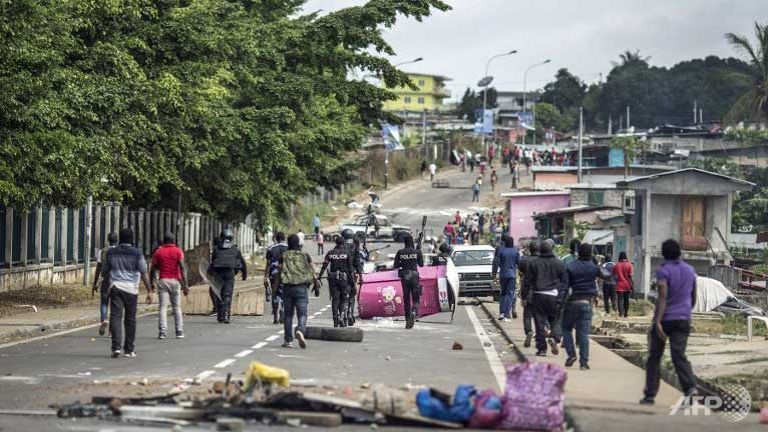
[0,203,256,292]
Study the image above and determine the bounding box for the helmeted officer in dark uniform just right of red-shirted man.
[211,229,248,324]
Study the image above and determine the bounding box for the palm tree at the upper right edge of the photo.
[725,22,768,120]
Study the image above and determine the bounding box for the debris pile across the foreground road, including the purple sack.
[57,362,566,431]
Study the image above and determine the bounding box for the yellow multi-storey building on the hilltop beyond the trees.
[384,72,451,111]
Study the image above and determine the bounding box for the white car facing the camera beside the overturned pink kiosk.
[451,245,501,301]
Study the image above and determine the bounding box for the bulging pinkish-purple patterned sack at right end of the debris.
[500,362,567,431]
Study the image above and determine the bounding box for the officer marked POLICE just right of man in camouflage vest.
[318,237,355,327]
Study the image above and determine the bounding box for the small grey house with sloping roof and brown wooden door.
[615,168,755,293]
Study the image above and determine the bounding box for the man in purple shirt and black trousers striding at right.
[640,239,698,405]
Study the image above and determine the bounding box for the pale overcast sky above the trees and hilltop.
[304,0,768,98]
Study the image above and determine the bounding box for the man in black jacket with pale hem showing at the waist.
[529,241,565,357]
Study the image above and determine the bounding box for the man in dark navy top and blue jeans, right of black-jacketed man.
[562,243,606,370]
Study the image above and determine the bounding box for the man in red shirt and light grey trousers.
[150,233,189,339]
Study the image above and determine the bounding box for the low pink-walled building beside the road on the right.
[501,191,570,243]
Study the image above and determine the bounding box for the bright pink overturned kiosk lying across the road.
[359,266,450,319]
